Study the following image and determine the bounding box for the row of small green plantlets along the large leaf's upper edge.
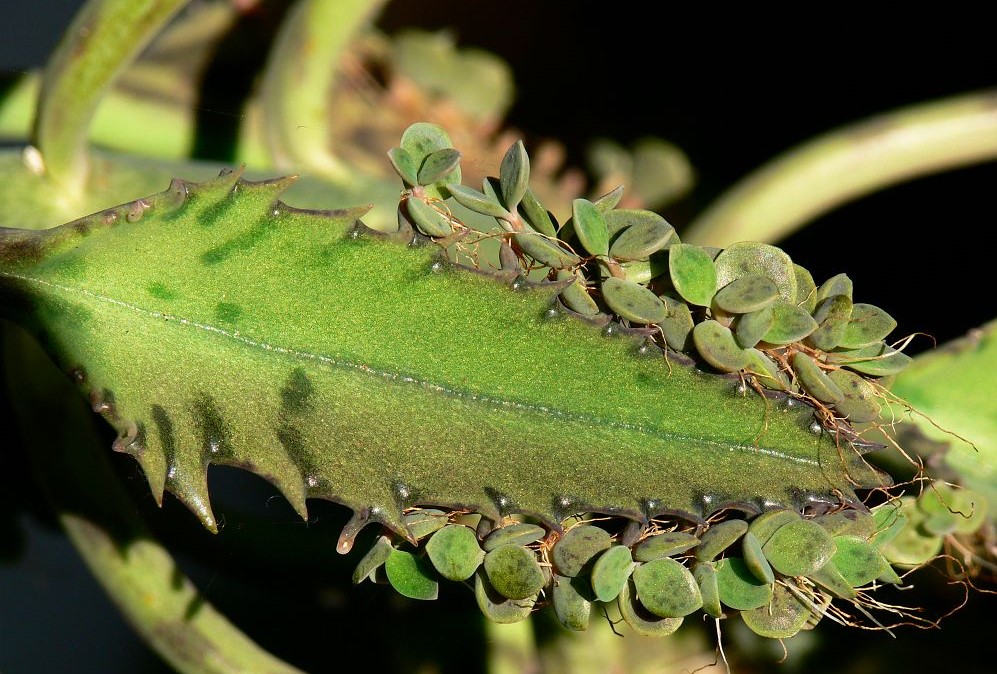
[389,123,910,428]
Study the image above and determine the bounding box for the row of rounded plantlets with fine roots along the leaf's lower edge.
[353,498,985,639]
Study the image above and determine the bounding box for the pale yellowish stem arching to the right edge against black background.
[682,90,997,246]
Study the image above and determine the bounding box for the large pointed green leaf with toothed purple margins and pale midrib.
[0,173,879,551]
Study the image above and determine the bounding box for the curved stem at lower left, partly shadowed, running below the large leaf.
[3,330,301,674]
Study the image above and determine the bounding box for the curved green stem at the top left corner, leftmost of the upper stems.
[33,0,187,199]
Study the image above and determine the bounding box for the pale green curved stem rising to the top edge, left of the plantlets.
[261,0,385,183]
